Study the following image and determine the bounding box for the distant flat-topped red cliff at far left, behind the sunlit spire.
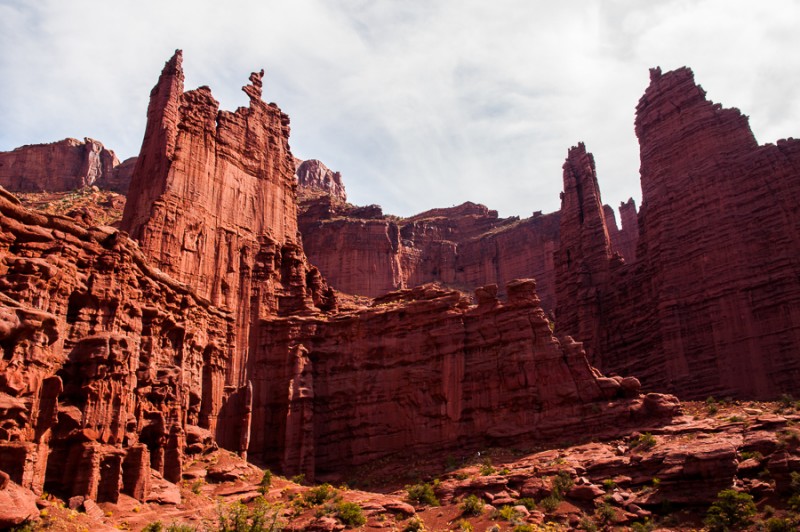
[0,138,130,193]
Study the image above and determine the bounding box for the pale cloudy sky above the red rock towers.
[0,0,800,217]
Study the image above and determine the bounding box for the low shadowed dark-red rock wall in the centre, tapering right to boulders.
[249,280,677,475]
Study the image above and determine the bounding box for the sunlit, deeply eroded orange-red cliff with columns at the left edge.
[0,185,234,502]
